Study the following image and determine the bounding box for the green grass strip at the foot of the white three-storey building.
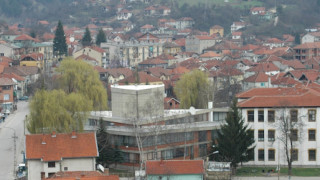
[236,167,320,177]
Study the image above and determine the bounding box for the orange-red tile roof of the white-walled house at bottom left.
[26,133,99,161]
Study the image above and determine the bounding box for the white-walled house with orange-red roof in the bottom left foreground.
[25,132,99,180]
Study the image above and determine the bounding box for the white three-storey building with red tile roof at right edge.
[237,84,320,166]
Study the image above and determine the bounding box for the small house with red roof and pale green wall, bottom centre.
[146,160,205,180]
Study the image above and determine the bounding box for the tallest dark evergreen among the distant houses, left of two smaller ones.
[53,21,67,56]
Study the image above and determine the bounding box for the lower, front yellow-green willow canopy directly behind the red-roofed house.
[27,90,92,133]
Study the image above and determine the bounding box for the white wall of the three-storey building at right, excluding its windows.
[241,107,320,166]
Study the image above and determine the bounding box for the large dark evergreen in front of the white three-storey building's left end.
[214,98,254,173]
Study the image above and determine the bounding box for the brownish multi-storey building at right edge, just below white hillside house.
[293,42,320,60]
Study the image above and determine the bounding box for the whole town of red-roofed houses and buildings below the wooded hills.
[0,0,320,180]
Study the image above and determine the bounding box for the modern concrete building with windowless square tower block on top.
[85,85,228,166]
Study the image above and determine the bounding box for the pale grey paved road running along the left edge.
[0,101,29,180]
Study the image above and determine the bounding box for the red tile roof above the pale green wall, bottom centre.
[146,160,204,175]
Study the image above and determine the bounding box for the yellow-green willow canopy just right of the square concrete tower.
[174,70,211,108]
